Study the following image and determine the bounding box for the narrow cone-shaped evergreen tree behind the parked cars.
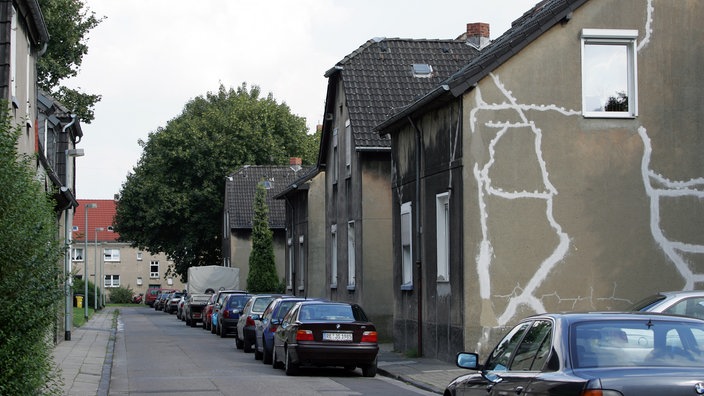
[247,183,279,293]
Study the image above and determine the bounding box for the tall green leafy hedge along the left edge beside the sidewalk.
[0,107,63,395]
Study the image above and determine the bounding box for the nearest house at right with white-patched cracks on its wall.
[377,0,704,360]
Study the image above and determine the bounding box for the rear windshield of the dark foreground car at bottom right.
[570,319,704,368]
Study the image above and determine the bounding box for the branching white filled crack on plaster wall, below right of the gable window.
[638,126,704,290]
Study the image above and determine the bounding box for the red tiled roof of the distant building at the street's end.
[73,199,120,242]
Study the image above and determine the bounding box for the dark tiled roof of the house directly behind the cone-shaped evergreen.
[225,165,307,229]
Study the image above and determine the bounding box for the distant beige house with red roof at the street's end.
[71,199,186,302]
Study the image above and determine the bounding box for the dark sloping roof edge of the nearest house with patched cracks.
[375,0,588,132]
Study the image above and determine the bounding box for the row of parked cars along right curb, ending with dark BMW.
[166,290,379,377]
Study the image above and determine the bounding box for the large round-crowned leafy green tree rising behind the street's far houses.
[115,84,317,281]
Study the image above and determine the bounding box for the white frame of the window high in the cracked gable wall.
[581,29,638,118]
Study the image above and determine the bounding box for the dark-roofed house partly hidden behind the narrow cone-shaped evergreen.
[222,160,307,289]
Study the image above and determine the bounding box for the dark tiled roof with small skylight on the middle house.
[325,38,479,149]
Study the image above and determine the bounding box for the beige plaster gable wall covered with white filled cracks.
[463,0,704,352]
